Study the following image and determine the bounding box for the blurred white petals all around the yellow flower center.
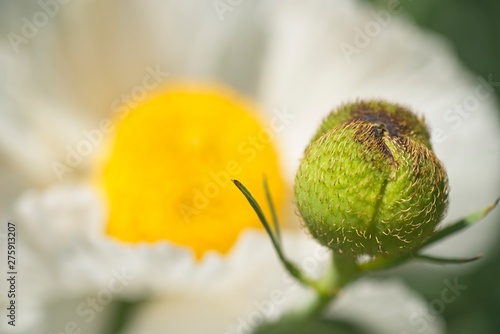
[0,0,500,333]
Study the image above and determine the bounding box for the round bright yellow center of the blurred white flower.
[98,85,284,258]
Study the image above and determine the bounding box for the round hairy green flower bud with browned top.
[295,100,448,256]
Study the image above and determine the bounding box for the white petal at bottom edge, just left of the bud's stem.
[108,234,324,334]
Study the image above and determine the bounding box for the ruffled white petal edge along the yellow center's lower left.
[13,185,307,295]
